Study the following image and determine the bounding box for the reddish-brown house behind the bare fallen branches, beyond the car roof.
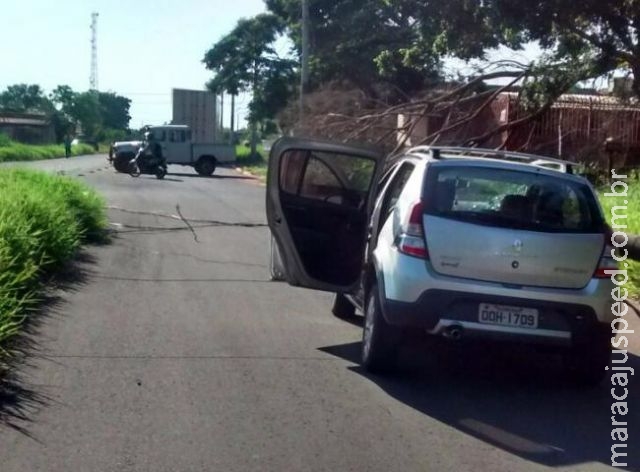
[398,92,640,167]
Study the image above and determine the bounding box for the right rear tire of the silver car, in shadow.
[563,326,611,387]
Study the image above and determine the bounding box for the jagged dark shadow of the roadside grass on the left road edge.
[0,251,96,441]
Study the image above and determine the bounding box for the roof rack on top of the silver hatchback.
[408,146,578,174]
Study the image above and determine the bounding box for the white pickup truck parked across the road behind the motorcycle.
[110,125,236,176]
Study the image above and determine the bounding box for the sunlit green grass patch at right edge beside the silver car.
[599,180,640,298]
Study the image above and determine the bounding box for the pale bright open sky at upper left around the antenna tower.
[0,0,265,128]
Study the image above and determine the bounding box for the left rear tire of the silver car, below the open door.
[362,285,402,374]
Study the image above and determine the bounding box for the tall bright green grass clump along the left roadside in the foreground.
[0,169,106,357]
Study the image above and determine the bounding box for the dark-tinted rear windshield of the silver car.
[424,166,604,233]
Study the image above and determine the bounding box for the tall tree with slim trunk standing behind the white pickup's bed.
[203,14,295,154]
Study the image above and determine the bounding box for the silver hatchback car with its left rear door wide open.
[267,138,617,385]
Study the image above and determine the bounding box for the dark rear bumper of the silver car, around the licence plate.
[381,289,602,345]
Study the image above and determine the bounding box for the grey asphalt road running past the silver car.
[0,156,640,472]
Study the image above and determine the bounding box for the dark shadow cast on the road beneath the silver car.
[320,343,640,470]
